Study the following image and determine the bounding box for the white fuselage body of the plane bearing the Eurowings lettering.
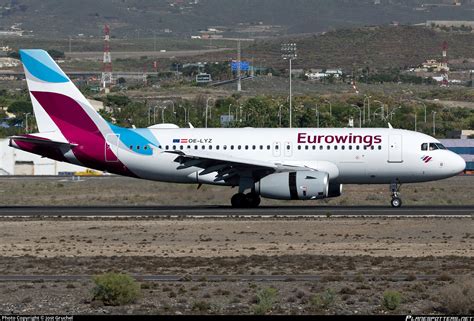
[112,128,465,185]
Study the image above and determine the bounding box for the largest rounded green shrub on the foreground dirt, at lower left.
[92,272,140,305]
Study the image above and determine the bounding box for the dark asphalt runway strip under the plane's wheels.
[0,205,474,217]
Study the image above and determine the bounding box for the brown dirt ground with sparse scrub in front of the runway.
[0,217,474,314]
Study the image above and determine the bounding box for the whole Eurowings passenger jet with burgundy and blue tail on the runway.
[9,49,466,208]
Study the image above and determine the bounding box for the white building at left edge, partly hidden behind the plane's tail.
[0,139,86,175]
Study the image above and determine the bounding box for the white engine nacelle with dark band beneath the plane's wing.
[255,171,329,200]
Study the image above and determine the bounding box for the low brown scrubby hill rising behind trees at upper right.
[245,26,474,70]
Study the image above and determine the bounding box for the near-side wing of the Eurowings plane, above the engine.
[167,150,308,184]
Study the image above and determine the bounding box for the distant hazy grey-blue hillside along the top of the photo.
[0,0,474,38]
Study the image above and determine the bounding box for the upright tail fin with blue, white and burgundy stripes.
[20,49,110,138]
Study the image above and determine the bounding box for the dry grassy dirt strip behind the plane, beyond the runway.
[0,176,474,206]
